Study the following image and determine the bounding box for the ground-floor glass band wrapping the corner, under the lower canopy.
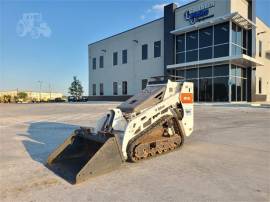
[176,64,247,102]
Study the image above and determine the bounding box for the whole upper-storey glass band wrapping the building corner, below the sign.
[175,22,248,64]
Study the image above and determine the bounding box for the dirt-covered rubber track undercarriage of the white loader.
[127,116,184,162]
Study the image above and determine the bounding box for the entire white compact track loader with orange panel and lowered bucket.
[47,77,193,183]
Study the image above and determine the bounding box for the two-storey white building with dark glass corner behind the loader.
[88,0,270,102]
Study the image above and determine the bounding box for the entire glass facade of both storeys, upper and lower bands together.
[175,22,249,102]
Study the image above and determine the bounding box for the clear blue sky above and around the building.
[0,0,270,95]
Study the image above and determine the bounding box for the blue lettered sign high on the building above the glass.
[184,2,215,25]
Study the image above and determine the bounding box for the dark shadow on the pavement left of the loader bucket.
[18,122,79,165]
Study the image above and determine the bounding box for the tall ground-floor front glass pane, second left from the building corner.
[199,78,212,102]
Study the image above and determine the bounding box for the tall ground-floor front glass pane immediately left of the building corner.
[214,77,229,102]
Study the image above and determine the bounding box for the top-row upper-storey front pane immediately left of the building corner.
[214,22,229,45]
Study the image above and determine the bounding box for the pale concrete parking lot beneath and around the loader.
[0,102,270,202]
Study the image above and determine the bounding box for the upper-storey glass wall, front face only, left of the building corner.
[175,22,230,64]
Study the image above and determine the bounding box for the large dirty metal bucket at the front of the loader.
[47,129,124,184]
